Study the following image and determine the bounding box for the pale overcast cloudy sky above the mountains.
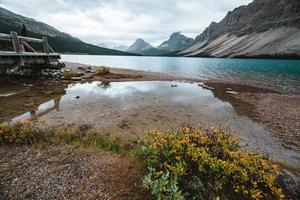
[0,0,252,45]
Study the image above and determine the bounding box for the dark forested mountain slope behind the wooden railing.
[0,7,132,55]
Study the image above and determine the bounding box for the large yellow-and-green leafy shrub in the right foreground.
[138,127,284,199]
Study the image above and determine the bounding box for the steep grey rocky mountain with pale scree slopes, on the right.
[178,0,300,58]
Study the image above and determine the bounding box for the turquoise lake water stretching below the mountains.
[62,55,300,94]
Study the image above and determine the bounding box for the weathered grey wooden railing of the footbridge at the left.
[0,31,60,66]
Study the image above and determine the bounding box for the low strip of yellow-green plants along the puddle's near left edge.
[0,121,123,153]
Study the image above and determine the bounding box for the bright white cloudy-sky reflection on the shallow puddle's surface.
[7,81,220,122]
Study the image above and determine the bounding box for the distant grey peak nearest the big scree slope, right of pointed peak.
[158,32,194,53]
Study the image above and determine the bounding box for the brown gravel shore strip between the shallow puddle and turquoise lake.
[66,63,300,152]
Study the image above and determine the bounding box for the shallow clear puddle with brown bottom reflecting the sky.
[0,81,300,166]
